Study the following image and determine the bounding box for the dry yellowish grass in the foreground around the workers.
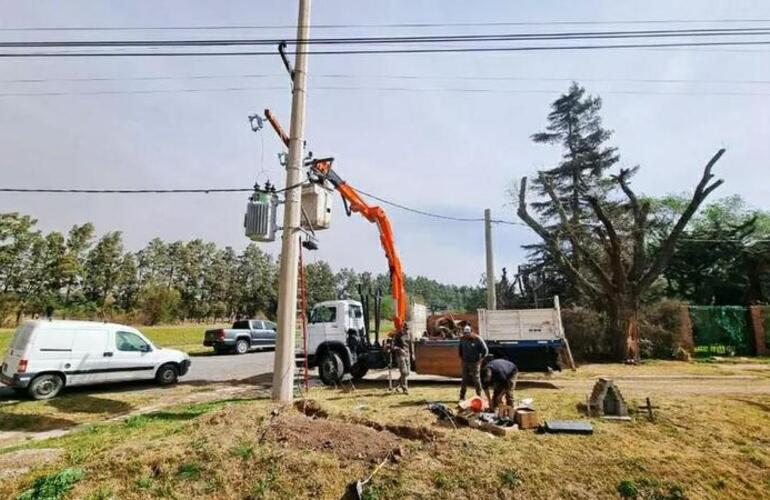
[0,362,770,499]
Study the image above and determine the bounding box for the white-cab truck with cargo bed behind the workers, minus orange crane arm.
[295,298,569,385]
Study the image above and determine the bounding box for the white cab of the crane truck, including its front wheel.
[304,300,369,384]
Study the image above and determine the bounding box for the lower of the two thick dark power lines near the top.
[6,40,770,58]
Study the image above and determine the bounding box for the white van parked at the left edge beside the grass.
[0,320,190,399]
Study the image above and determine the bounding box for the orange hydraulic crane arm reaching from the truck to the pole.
[265,109,407,331]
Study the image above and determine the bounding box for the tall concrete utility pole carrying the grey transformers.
[273,0,310,402]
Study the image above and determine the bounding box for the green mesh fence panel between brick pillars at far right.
[690,306,753,354]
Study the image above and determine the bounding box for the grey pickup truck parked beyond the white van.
[203,319,278,354]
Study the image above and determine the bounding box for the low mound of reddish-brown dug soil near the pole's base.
[268,414,400,462]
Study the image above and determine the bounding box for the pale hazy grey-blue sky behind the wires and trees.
[0,0,770,285]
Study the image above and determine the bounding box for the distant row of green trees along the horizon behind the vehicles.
[0,213,484,325]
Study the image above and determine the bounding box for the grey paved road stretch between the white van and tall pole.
[181,351,274,382]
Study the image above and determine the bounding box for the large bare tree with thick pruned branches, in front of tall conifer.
[517,149,725,360]
